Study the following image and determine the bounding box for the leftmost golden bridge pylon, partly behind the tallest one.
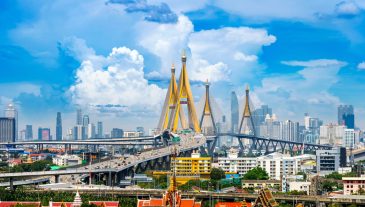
[157,65,187,132]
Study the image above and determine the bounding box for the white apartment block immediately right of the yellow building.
[218,149,256,175]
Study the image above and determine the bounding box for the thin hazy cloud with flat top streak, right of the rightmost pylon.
[254,59,347,120]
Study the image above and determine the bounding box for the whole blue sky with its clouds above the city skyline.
[0,0,365,133]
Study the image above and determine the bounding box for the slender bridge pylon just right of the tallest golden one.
[199,80,217,135]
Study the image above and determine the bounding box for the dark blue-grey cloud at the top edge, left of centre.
[108,0,177,23]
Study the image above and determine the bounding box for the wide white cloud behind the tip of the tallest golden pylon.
[138,15,276,83]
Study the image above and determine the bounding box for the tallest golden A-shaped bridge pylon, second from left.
[168,51,201,133]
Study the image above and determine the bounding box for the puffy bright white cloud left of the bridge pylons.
[69,36,165,115]
